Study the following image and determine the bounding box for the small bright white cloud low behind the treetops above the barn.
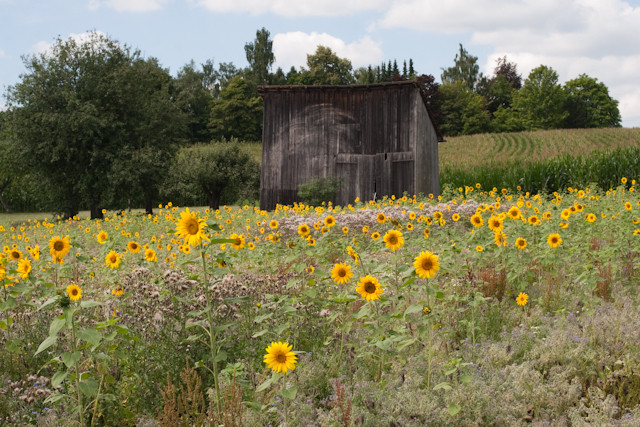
[273,31,383,72]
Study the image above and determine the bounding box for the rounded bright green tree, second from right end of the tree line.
[513,65,568,130]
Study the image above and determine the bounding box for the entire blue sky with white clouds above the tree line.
[0,0,640,127]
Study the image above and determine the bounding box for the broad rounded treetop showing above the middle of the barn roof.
[301,46,355,85]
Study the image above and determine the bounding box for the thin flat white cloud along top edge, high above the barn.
[198,0,387,17]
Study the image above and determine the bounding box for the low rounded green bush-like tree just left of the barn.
[163,140,260,209]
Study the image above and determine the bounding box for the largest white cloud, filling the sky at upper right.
[376,0,640,126]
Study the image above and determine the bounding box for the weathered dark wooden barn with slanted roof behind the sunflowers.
[258,81,442,210]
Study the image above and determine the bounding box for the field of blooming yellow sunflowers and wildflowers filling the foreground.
[0,182,640,427]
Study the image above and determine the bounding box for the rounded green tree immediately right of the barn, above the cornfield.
[439,80,489,136]
